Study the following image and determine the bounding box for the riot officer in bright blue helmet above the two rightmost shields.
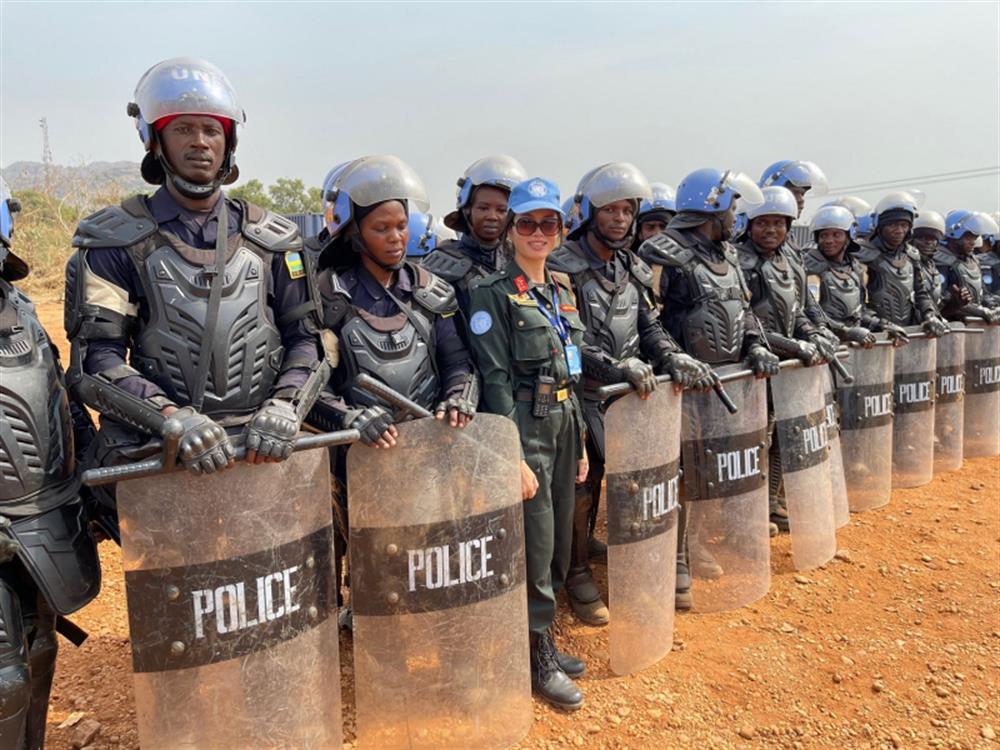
[934,210,1000,323]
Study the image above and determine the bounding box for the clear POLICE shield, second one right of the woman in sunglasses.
[684,365,771,619]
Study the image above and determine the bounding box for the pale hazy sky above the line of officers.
[0,0,1000,220]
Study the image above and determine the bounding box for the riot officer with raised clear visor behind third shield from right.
[856,192,948,336]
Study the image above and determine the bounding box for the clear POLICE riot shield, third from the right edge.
[892,329,937,487]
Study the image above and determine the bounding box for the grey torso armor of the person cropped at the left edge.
[0,281,77,516]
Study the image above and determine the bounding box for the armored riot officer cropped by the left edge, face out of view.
[0,179,101,750]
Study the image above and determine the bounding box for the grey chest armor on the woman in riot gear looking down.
[323,272,441,409]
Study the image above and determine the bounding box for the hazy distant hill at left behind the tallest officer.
[0,161,150,198]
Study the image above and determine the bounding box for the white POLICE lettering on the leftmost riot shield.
[191,565,300,638]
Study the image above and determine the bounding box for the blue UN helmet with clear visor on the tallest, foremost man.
[126,57,246,198]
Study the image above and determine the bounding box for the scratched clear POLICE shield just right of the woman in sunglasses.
[604,384,681,675]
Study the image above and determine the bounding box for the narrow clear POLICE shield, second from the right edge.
[934,333,964,474]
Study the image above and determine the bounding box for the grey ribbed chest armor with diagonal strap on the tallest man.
[130,233,284,418]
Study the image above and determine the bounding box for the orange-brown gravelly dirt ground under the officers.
[31,303,1000,750]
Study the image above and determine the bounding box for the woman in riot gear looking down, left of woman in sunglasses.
[307,156,479,616]
